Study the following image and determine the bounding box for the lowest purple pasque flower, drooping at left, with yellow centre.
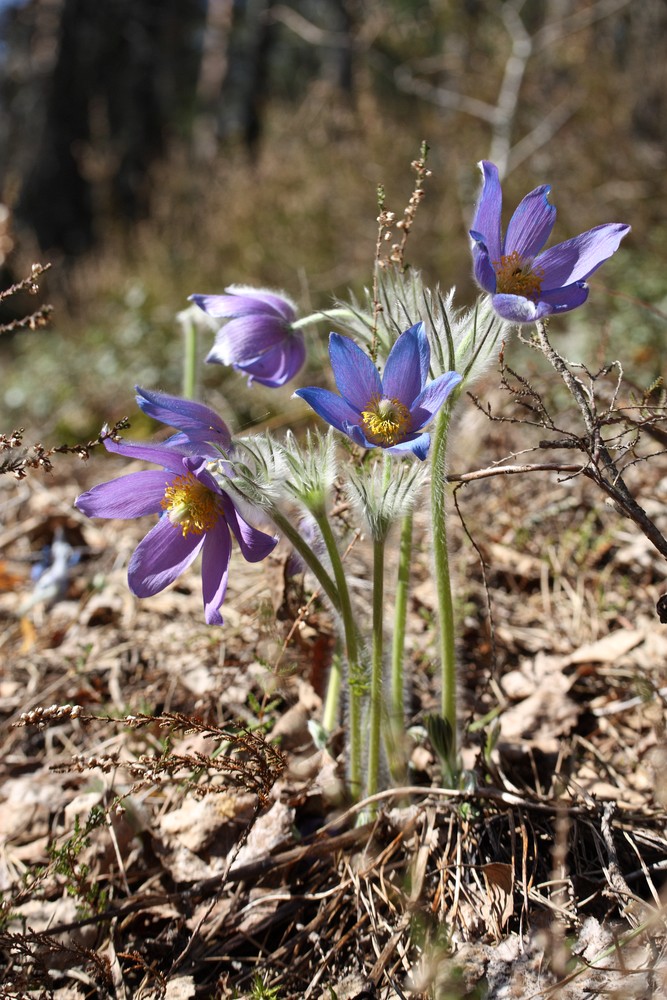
[75,440,276,625]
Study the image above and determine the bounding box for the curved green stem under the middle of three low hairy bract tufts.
[315,514,363,799]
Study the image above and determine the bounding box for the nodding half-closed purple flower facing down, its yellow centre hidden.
[190,285,306,387]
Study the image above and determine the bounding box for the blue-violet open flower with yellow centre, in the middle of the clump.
[294,323,461,460]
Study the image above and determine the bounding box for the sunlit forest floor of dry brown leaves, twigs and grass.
[0,398,667,1000]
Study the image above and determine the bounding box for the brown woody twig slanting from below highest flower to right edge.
[536,322,667,568]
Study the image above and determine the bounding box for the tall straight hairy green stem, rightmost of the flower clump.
[431,400,457,770]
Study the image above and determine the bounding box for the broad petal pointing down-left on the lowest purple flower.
[127,514,204,597]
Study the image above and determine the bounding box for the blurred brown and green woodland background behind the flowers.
[0,0,667,439]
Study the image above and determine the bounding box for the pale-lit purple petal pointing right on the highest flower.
[533,222,630,289]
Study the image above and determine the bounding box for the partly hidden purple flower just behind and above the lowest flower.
[134,385,232,458]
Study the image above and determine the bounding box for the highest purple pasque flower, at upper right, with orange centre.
[470,160,630,323]
